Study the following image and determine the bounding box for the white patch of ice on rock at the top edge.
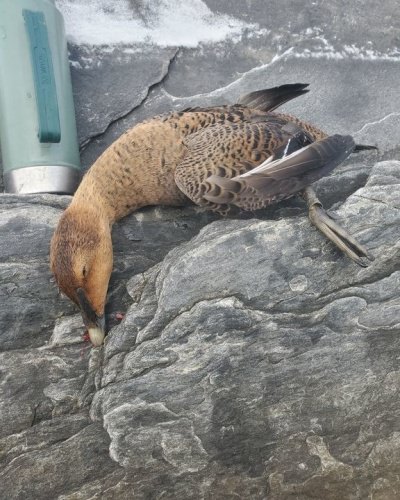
[56,0,258,47]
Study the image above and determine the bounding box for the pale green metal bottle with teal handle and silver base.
[0,0,81,193]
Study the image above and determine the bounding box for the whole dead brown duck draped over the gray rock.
[50,84,373,346]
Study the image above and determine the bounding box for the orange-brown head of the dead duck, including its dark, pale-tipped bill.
[50,205,113,347]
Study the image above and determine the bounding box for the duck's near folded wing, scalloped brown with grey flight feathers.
[175,120,355,213]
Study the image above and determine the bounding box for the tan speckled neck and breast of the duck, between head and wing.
[70,122,186,224]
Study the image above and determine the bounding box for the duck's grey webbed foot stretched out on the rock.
[303,187,374,267]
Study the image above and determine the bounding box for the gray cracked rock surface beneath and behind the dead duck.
[0,0,400,500]
